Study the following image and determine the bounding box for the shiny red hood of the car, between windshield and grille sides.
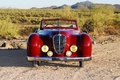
[38,30,80,55]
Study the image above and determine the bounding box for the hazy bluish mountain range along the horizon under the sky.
[31,1,120,9]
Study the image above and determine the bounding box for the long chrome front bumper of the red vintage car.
[27,56,92,61]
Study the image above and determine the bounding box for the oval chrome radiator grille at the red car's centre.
[53,34,66,54]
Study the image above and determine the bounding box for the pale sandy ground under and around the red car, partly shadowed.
[0,36,120,80]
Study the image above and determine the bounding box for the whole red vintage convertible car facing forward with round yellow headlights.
[27,18,92,67]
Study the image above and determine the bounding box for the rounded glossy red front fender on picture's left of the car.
[27,33,43,57]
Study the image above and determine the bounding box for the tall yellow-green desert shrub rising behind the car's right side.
[85,5,114,34]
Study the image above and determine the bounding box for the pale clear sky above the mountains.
[0,0,120,9]
